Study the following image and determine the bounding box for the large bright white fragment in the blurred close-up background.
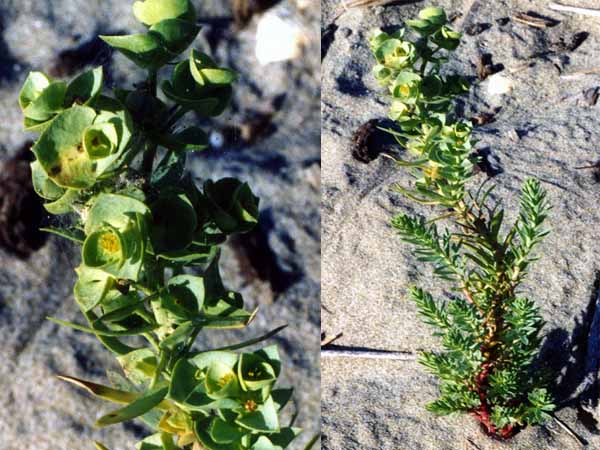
[256,12,304,65]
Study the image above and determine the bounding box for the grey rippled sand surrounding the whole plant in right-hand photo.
[321,0,600,450]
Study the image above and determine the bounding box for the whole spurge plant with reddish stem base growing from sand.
[369,8,554,438]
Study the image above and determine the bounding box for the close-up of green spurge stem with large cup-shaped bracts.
[19,0,299,450]
